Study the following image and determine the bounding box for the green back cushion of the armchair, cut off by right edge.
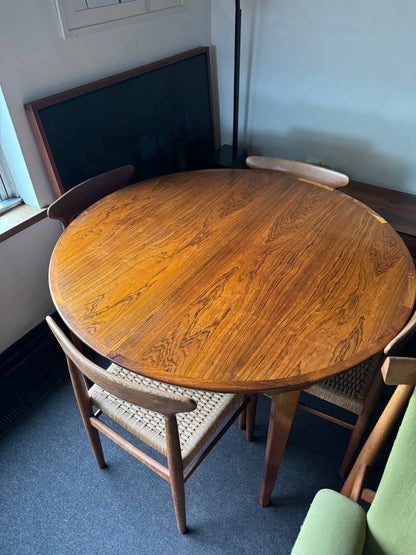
[364,390,416,555]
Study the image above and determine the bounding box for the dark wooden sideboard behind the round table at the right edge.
[340,181,416,259]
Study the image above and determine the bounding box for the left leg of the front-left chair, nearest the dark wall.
[67,358,107,468]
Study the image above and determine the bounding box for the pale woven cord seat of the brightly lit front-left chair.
[89,364,241,467]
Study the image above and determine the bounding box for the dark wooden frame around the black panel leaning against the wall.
[24,46,215,198]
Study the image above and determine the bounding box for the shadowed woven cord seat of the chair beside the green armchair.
[305,353,383,414]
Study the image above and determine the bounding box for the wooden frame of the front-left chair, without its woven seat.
[46,316,250,533]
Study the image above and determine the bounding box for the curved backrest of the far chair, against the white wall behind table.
[246,156,350,189]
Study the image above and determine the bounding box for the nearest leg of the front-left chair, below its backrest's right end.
[165,416,186,534]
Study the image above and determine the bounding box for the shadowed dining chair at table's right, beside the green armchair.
[247,311,416,477]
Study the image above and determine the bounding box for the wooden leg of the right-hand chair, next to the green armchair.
[339,370,384,478]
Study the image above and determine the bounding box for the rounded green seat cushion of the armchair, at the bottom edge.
[292,489,366,555]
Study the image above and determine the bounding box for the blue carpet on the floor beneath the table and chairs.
[0,381,386,555]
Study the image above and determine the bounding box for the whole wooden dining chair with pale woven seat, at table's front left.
[46,316,249,533]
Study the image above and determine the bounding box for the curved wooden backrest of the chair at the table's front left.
[46,316,196,416]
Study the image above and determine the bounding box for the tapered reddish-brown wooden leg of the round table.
[260,391,300,507]
